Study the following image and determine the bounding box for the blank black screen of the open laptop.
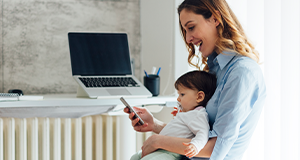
[68,32,131,76]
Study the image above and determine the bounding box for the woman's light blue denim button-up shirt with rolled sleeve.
[206,52,266,160]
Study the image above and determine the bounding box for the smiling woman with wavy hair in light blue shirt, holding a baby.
[124,0,266,160]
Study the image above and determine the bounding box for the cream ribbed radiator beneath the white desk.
[0,115,152,160]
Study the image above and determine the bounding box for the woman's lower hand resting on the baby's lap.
[142,134,162,157]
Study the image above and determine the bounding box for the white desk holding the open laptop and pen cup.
[0,94,177,118]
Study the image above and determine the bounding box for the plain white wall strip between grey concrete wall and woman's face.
[140,0,188,95]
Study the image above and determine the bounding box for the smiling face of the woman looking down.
[179,9,219,57]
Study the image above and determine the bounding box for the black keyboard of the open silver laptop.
[79,77,139,87]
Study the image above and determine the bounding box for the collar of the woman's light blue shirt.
[207,51,237,70]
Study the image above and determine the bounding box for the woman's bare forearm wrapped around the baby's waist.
[142,135,217,157]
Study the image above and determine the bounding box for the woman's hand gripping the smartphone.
[124,107,154,132]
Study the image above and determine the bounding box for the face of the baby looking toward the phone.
[177,85,198,112]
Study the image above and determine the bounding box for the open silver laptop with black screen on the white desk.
[68,32,152,98]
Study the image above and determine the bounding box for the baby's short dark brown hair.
[174,70,217,107]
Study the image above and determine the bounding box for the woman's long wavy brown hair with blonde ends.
[178,0,259,71]
